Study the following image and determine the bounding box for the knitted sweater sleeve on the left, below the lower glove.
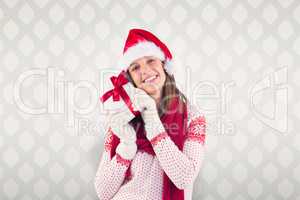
[94,129,131,200]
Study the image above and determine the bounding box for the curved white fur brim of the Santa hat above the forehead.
[118,41,165,70]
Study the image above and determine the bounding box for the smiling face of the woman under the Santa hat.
[128,56,166,96]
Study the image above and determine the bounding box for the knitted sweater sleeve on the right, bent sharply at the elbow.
[150,102,205,189]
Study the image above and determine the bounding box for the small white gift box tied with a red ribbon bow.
[100,71,140,122]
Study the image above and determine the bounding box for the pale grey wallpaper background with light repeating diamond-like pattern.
[0,0,300,200]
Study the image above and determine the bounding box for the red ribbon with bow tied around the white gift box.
[100,71,140,116]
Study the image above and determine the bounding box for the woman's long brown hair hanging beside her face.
[127,61,187,116]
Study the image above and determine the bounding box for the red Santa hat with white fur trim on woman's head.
[118,29,173,75]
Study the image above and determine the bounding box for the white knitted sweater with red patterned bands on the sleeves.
[94,102,205,200]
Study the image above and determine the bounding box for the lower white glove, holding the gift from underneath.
[107,111,137,160]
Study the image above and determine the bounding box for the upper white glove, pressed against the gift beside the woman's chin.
[131,88,165,140]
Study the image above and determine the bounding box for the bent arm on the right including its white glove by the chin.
[133,88,205,189]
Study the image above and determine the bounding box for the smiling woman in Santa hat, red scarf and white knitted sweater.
[94,29,205,200]
